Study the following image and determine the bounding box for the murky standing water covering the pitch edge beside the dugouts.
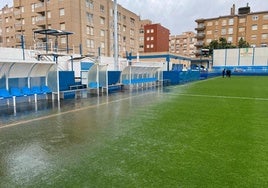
[0,89,170,187]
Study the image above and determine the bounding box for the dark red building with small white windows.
[144,24,170,53]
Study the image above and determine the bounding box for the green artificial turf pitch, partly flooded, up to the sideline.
[0,77,268,187]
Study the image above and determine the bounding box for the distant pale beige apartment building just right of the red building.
[169,31,197,57]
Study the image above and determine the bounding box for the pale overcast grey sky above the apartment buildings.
[0,0,268,34]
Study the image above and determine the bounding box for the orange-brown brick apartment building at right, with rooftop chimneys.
[195,5,268,55]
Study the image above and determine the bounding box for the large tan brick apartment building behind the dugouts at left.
[0,0,140,56]
